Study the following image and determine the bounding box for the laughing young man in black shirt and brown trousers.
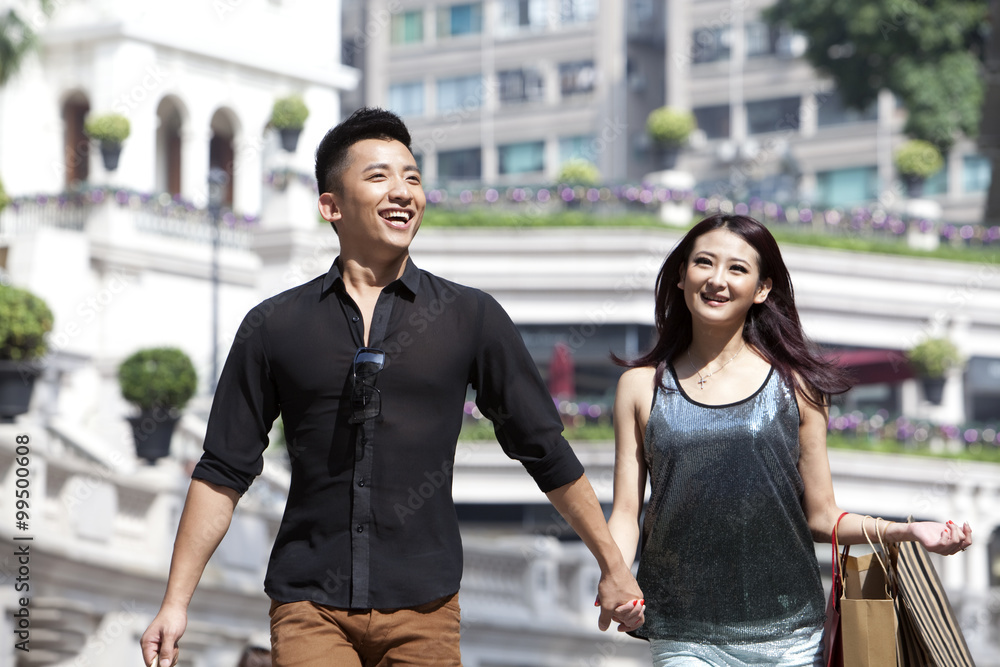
[141,109,643,667]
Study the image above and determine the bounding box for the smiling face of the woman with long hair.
[677,229,771,324]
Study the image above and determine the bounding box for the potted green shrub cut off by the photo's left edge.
[0,284,53,423]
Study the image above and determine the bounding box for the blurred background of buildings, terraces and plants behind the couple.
[0,0,1000,667]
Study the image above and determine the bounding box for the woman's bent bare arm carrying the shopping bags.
[796,386,972,556]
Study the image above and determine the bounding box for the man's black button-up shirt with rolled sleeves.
[192,259,583,609]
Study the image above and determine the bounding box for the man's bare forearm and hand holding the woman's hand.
[545,475,644,632]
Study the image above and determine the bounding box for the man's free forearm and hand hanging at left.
[139,479,240,667]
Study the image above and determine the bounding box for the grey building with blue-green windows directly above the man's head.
[344,0,663,185]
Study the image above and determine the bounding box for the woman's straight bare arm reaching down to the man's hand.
[608,367,655,564]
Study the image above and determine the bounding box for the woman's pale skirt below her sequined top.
[649,626,823,667]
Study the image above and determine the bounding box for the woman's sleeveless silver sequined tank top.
[635,366,825,644]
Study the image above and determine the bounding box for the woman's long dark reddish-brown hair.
[614,214,851,407]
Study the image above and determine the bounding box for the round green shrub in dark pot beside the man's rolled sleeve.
[118,347,198,463]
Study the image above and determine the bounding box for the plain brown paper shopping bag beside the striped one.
[840,520,898,667]
